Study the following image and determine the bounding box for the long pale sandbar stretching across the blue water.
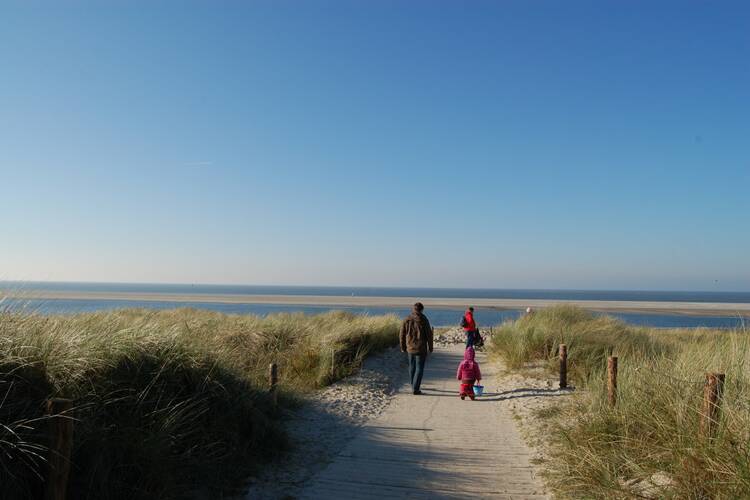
[0,290,750,316]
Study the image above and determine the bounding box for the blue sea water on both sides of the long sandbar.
[0,281,750,328]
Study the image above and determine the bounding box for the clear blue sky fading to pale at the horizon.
[0,0,750,291]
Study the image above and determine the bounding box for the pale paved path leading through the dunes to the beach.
[298,346,547,499]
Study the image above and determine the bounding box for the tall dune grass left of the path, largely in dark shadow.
[0,309,399,499]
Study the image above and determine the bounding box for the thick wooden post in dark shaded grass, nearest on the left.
[44,398,73,500]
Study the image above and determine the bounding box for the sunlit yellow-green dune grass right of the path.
[490,306,750,499]
